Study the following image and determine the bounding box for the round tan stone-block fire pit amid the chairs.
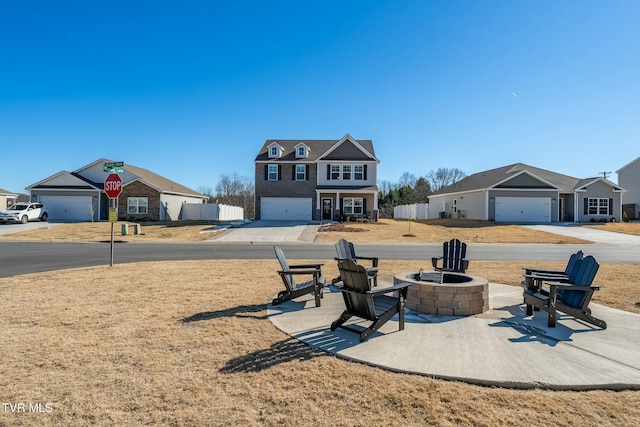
[393,271,489,316]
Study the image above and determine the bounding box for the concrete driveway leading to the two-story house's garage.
[207,221,320,243]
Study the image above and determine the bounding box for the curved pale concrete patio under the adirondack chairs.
[268,284,640,390]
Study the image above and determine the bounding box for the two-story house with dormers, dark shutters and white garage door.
[255,135,380,221]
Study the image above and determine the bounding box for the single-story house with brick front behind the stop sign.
[27,159,208,221]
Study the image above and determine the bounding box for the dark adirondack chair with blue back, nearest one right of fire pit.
[524,255,607,329]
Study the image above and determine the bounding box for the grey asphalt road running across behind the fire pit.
[0,242,640,277]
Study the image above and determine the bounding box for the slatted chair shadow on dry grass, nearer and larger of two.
[220,338,327,374]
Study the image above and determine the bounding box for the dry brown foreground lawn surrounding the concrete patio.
[0,260,640,426]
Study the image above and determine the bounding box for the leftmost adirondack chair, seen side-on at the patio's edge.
[271,246,325,307]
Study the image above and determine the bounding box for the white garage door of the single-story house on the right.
[496,197,551,222]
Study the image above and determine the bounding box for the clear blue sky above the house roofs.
[0,0,640,192]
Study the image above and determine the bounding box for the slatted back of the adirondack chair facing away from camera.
[338,258,376,320]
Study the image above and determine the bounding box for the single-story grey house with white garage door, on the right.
[429,163,625,223]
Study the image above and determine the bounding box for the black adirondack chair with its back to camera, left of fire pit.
[331,259,410,342]
